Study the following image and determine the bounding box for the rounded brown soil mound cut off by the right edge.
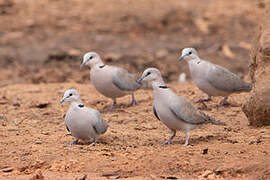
[243,3,270,126]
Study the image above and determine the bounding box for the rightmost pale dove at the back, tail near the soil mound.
[178,48,252,105]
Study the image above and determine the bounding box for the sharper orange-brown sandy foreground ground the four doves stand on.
[0,82,270,179]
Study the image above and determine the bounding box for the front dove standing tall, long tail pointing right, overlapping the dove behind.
[139,68,225,146]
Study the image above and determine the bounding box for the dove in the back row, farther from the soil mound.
[80,52,141,110]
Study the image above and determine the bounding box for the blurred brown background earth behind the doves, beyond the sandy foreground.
[0,0,266,83]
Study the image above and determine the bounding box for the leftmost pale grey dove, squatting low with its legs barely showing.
[60,89,108,145]
